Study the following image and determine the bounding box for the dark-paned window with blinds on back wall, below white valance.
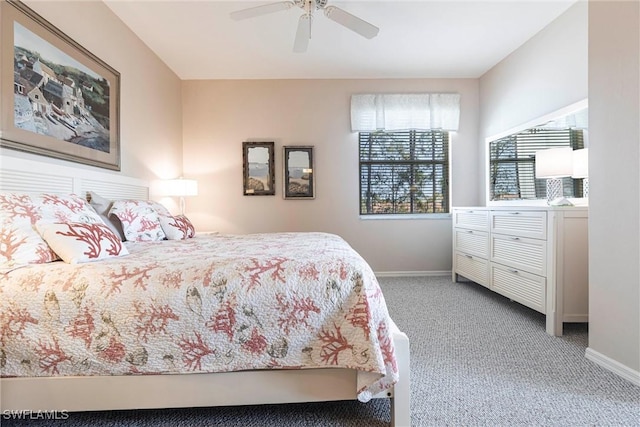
[359,130,449,215]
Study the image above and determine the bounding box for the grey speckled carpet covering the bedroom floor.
[0,277,640,427]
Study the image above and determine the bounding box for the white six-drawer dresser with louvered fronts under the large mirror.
[452,207,589,335]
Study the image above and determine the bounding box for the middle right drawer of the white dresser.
[490,234,547,276]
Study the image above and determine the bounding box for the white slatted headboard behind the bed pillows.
[0,156,149,200]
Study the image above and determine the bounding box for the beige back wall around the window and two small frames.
[183,79,478,272]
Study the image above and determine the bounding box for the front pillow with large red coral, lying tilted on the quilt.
[38,222,129,264]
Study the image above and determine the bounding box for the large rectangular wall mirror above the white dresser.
[487,102,588,202]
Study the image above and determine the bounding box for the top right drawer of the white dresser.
[491,211,547,240]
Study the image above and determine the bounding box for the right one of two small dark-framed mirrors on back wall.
[283,145,315,199]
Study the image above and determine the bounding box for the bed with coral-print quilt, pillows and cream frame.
[0,193,409,425]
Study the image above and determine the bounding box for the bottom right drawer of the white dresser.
[490,263,547,314]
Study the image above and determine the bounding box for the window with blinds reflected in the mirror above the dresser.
[489,127,585,200]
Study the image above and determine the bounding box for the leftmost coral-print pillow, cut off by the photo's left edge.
[0,193,57,269]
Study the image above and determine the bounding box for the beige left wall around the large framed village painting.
[0,1,182,179]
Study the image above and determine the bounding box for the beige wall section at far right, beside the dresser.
[587,1,640,374]
